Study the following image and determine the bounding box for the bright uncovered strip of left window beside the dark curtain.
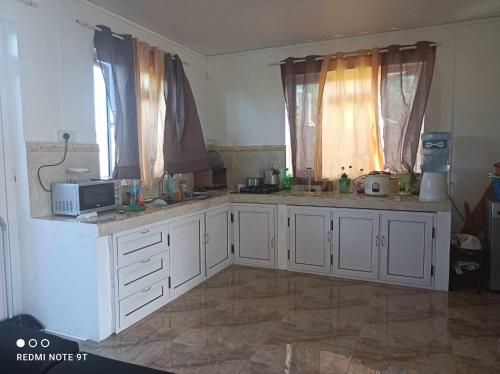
[94,61,115,178]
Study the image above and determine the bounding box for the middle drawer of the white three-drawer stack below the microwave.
[118,251,168,299]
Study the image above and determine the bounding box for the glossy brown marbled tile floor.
[81,266,500,374]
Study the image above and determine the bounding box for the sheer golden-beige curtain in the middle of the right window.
[315,49,384,179]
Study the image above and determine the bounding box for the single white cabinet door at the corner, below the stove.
[233,204,276,267]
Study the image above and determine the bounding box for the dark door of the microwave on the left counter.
[79,183,115,214]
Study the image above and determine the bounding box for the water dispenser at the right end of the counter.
[419,132,451,201]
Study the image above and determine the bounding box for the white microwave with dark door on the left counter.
[51,180,118,217]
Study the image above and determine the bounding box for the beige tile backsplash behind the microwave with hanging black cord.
[26,142,99,218]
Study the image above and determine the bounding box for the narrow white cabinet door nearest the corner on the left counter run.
[205,206,231,276]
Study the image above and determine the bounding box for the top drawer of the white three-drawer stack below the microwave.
[116,227,168,268]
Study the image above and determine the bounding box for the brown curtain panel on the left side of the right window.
[281,56,321,178]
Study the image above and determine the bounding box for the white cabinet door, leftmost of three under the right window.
[288,207,331,273]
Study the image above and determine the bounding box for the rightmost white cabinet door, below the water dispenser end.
[380,212,433,286]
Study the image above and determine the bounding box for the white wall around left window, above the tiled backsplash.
[0,0,206,143]
